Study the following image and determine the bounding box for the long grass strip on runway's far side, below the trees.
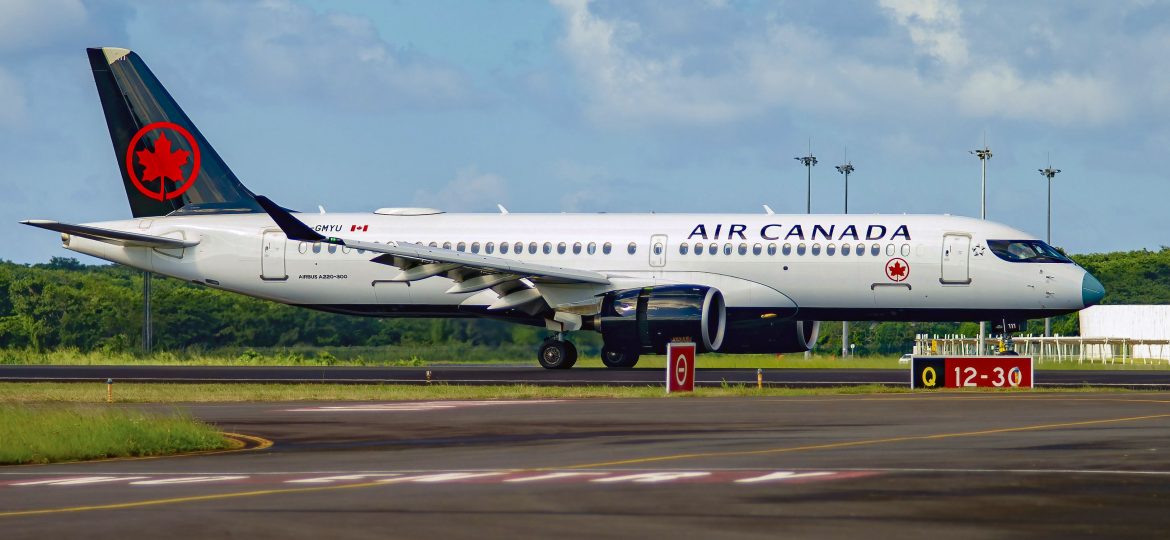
[0,346,1170,371]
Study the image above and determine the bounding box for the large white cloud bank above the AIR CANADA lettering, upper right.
[552,0,1129,126]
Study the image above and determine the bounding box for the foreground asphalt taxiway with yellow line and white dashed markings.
[0,392,1170,540]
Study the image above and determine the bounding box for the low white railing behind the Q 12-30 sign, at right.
[914,334,1170,365]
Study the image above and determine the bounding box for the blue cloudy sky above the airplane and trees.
[0,0,1170,263]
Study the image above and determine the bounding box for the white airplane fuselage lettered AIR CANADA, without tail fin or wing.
[57,214,1086,320]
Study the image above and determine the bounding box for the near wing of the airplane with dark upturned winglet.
[256,195,610,313]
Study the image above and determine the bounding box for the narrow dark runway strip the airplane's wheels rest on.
[0,366,1170,390]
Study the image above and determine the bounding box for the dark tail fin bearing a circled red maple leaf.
[87,47,263,217]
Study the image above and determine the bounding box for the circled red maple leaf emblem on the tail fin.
[126,122,199,201]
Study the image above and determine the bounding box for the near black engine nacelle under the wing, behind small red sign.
[593,285,727,354]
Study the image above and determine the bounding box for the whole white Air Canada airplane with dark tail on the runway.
[22,48,1104,369]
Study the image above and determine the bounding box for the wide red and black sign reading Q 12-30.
[910,356,1033,388]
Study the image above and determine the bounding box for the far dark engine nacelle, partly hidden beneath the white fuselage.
[720,311,820,354]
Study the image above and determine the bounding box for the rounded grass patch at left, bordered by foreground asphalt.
[0,400,230,465]
